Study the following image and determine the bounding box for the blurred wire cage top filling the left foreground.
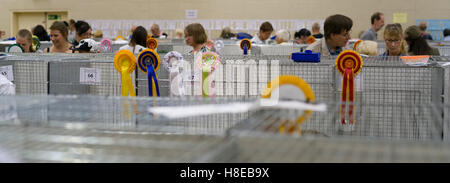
[0,96,260,163]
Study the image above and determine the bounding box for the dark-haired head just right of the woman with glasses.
[405,25,432,55]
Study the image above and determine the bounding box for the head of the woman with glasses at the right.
[383,24,406,56]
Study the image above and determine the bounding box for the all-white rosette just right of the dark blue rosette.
[163,51,184,96]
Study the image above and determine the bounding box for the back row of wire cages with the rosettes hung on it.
[0,54,450,103]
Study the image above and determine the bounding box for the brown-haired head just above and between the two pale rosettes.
[184,23,208,46]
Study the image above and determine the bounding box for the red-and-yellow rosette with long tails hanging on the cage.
[336,50,363,124]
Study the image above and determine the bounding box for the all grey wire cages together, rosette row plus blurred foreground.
[0,42,450,162]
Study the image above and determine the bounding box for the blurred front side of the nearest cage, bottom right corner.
[206,135,450,163]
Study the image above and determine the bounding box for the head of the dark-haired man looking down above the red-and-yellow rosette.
[323,14,353,47]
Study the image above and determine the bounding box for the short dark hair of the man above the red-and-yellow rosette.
[323,14,353,39]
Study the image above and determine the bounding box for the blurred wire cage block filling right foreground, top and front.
[206,103,450,163]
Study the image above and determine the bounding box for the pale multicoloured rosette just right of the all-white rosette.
[197,52,220,97]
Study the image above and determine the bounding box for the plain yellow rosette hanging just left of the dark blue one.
[114,50,136,96]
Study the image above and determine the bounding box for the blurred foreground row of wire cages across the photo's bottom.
[0,95,450,162]
